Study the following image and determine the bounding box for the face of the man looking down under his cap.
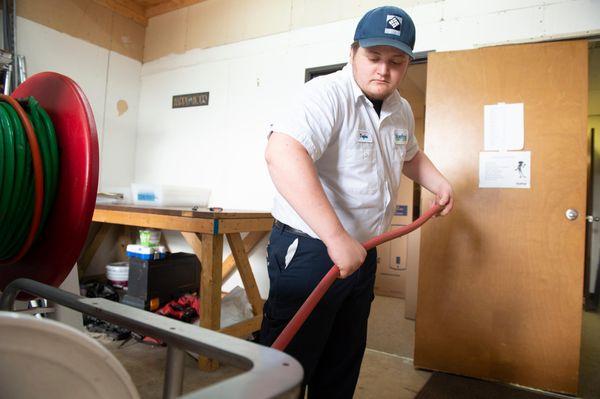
[350,46,410,100]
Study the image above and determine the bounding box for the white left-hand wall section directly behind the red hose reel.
[16,17,142,188]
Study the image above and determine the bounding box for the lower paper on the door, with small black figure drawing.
[479,151,531,188]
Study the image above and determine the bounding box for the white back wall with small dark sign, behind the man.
[135,0,600,296]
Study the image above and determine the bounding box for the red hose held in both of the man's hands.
[271,205,444,351]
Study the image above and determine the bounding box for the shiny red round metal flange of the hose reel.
[0,72,99,290]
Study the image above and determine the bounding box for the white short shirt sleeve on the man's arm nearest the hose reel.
[269,78,338,161]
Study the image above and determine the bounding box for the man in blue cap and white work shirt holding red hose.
[260,7,453,398]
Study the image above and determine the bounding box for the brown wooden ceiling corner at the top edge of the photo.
[94,0,204,26]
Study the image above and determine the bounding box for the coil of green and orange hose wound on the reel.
[0,95,59,265]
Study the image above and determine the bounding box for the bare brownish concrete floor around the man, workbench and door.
[100,297,600,399]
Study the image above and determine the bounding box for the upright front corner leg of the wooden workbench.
[198,234,223,371]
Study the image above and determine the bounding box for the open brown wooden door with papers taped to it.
[415,41,588,393]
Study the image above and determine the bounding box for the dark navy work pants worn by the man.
[260,226,377,399]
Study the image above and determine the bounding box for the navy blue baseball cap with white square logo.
[354,6,415,59]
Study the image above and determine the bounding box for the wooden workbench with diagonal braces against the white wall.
[84,205,273,370]
